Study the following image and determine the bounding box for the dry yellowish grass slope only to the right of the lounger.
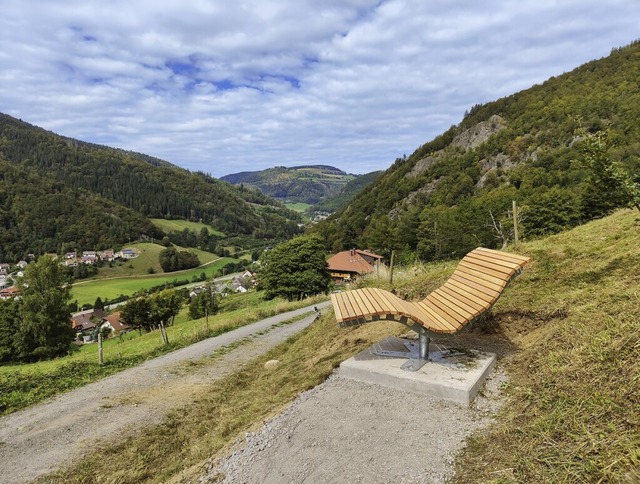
[457,211,640,483]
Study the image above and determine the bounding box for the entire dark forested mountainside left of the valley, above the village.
[0,114,300,257]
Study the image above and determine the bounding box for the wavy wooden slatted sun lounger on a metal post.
[331,247,529,366]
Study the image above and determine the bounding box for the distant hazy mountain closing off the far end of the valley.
[220,165,358,205]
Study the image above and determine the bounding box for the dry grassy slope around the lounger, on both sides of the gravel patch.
[45,210,640,482]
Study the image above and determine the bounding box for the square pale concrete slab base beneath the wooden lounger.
[338,337,496,406]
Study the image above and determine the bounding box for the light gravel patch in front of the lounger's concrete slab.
[199,360,505,484]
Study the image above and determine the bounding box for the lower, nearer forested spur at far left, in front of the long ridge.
[0,159,162,262]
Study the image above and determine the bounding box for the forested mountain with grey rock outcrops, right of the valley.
[312,42,640,260]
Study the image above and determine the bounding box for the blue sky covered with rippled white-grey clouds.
[0,0,640,177]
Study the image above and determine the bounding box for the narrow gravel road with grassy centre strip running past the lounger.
[0,301,330,484]
